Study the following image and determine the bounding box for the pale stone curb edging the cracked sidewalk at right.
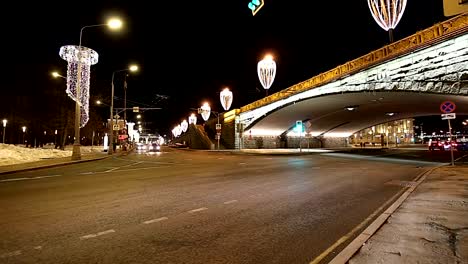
[329,164,447,264]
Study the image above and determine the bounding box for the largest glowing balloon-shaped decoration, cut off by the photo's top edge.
[367,0,407,42]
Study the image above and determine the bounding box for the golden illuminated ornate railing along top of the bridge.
[240,13,468,113]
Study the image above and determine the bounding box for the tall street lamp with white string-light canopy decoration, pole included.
[60,18,122,160]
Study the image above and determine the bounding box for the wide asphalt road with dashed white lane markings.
[0,147,442,263]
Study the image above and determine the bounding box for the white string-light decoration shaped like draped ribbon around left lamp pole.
[59,45,99,127]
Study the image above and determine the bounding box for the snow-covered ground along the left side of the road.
[0,144,102,166]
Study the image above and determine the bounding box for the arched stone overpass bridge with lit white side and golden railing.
[207,13,468,148]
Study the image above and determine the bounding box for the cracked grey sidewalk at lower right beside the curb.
[340,165,468,264]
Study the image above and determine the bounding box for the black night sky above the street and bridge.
[6,0,447,136]
